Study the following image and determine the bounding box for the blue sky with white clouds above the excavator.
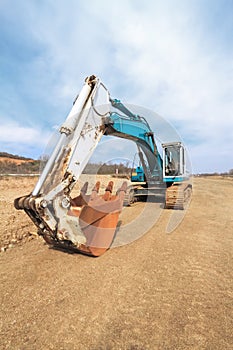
[0,0,233,173]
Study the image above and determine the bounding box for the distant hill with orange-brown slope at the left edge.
[0,152,40,174]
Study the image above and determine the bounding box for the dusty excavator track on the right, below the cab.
[165,183,192,210]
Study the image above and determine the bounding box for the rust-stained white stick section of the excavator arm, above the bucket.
[32,76,110,200]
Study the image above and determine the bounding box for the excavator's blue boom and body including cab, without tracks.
[105,100,186,185]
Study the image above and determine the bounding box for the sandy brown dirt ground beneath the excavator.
[0,177,233,350]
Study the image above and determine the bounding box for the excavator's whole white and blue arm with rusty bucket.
[14,76,190,256]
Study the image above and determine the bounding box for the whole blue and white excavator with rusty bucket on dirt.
[14,75,192,257]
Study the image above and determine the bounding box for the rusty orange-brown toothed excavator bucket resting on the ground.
[68,181,127,256]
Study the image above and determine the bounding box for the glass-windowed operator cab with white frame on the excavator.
[162,142,186,182]
